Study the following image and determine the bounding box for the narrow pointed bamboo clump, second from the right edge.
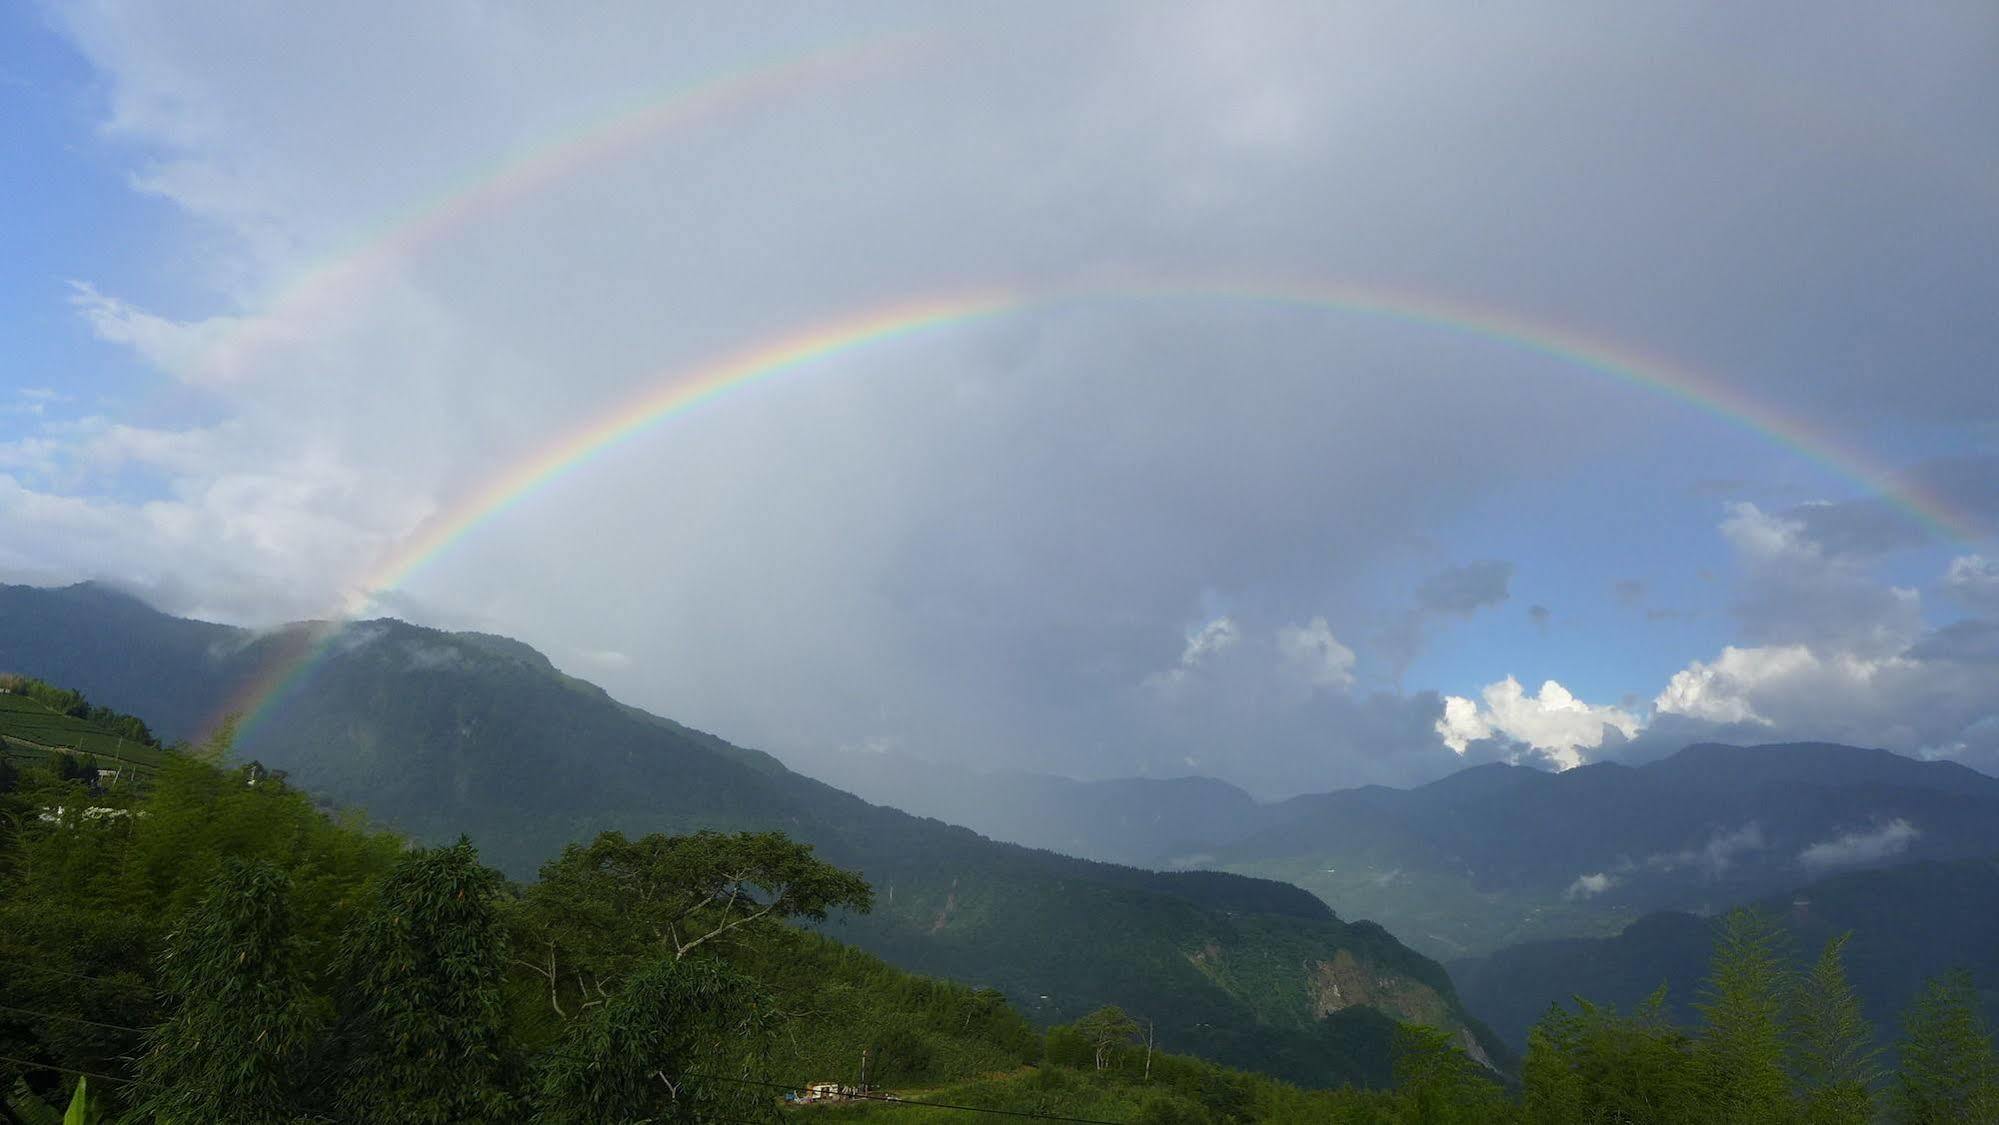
[1789,933,1881,1125]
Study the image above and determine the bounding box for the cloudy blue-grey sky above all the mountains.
[0,0,1999,795]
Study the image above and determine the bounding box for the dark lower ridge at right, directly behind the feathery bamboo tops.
[1451,859,1999,1047]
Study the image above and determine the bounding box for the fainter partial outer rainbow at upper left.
[192,34,928,380]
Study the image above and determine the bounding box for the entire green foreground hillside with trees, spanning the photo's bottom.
[0,703,1999,1125]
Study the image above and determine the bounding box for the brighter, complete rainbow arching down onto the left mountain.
[202,282,1983,731]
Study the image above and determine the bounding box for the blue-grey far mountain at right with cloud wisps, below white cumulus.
[1211,743,1999,957]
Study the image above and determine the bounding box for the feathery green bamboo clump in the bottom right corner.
[1889,971,1999,1125]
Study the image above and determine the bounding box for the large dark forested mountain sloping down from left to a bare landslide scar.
[0,585,1507,1083]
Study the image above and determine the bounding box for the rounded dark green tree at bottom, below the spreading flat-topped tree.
[534,955,774,1125]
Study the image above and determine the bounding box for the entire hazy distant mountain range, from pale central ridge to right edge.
[807,743,1999,959]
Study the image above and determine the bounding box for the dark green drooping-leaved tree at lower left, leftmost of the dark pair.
[140,861,324,1125]
